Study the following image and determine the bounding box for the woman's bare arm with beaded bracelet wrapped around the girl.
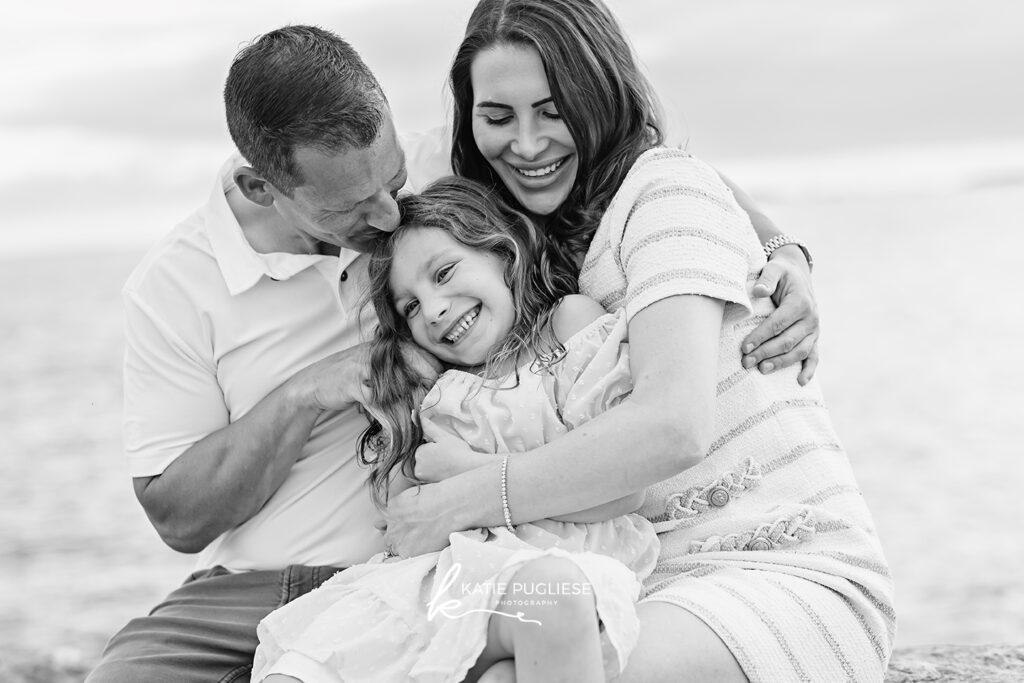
[387,295,724,556]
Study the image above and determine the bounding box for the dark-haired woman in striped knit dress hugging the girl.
[387,0,895,681]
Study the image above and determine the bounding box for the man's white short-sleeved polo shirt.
[123,135,443,569]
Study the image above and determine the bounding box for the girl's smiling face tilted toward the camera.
[389,227,515,367]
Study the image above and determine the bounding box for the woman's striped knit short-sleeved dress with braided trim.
[580,148,895,683]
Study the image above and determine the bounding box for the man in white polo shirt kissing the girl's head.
[88,27,819,683]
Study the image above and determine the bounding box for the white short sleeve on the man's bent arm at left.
[123,289,228,477]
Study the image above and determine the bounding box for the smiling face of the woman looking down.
[470,45,579,216]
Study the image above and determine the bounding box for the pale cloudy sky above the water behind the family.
[0,0,1024,258]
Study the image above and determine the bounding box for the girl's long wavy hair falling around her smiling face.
[358,176,577,507]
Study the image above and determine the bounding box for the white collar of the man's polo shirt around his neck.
[204,153,359,296]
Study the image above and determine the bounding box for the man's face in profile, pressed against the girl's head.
[271,115,407,251]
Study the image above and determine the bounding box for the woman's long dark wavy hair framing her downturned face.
[450,0,664,269]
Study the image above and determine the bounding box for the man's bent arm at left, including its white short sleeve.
[123,288,374,552]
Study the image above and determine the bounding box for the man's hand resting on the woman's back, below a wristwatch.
[741,245,820,385]
